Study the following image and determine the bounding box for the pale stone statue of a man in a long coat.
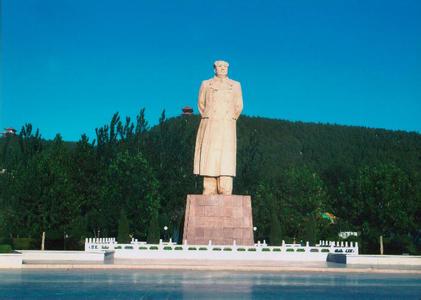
[194,61,243,195]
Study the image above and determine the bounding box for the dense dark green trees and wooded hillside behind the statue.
[0,110,421,253]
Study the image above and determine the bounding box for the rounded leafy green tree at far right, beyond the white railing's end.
[344,164,417,253]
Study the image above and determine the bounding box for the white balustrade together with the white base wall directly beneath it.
[85,238,358,260]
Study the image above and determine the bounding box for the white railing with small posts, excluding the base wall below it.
[85,238,358,254]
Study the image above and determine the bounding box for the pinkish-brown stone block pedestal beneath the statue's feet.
[183,195,254,245]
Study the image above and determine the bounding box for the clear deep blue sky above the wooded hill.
[0,0,421,140]
